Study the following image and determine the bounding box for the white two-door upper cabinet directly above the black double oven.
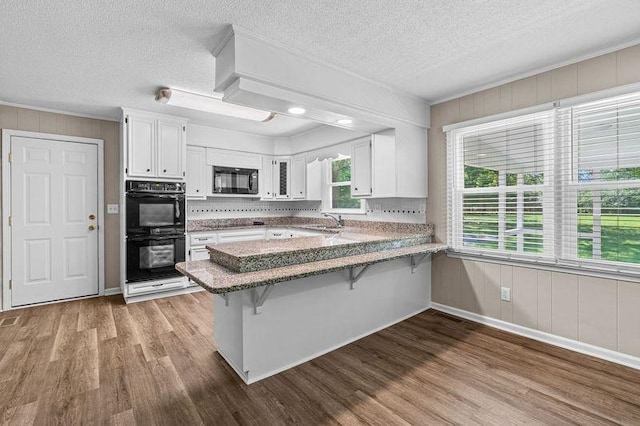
[123,110,187,180]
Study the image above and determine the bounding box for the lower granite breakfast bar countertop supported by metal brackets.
[176,240,447,294]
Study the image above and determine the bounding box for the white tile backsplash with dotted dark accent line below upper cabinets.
[187,197,426,223]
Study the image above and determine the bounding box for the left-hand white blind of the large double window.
[448,111,555,257]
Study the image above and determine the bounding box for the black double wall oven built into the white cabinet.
[126,181,186,283]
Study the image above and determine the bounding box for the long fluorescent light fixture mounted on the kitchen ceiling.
[156,88,275,122]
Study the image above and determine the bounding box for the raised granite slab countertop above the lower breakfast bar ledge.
[207,228,431,272]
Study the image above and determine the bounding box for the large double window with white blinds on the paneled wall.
[447,93,640,272]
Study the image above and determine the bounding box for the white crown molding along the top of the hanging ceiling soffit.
[225,25,431,106]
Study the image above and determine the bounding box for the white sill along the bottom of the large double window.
[447,249,640,283]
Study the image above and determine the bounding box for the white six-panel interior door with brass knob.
[11,136,101,306]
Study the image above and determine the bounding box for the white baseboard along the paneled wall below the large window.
[431,302,640,370]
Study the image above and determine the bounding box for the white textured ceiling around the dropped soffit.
[0,0,640,135]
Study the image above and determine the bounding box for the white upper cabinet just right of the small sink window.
[351,131,396,198]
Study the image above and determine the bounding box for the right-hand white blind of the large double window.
[557,94,640,265]
